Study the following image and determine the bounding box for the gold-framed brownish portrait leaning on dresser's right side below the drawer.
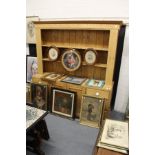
[80,95,104,128]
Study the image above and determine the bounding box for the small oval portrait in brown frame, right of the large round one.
[85,48,97,65]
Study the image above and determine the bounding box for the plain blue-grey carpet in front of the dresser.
[26,114,99,155]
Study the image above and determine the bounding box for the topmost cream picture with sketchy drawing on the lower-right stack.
[101,119,129,149]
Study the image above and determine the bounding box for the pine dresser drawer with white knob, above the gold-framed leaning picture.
[86,88,109,99]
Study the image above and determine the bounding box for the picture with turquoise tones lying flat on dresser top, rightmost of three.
[86,79,105,88]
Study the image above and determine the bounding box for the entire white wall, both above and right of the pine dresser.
[26,0,129,112]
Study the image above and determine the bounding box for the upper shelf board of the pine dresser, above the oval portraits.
[42,44,108,51]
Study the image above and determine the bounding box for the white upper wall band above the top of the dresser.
[26,0,129,20]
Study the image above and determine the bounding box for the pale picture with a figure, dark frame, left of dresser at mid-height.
[26,55,38,82]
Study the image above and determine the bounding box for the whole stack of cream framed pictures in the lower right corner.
[97,119,129,154]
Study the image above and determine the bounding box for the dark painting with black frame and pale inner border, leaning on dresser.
[51,88,75,118]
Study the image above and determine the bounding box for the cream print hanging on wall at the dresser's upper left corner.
[26,16,39,44]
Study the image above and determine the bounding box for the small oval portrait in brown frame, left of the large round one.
[48,46,60,61]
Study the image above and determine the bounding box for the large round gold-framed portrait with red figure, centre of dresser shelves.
[61,49,81,71]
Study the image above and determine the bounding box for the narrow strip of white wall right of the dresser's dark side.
[114,26,129,113]
